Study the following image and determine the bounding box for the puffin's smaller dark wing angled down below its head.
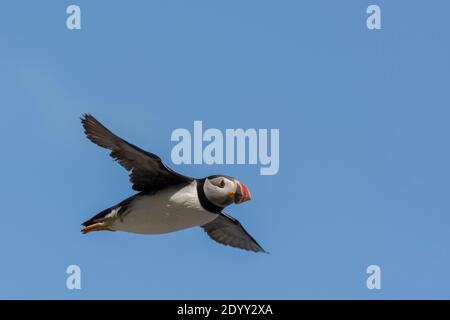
[202,213,267,253]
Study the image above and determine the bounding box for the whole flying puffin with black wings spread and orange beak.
[81,114,267,253]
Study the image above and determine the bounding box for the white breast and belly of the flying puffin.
[111,181,218,234]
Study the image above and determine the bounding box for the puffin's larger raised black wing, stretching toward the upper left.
[81,114,193,191]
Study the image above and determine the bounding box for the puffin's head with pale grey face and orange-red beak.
[203,176,251,207]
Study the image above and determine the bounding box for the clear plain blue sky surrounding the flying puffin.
[0,0,450,299]
